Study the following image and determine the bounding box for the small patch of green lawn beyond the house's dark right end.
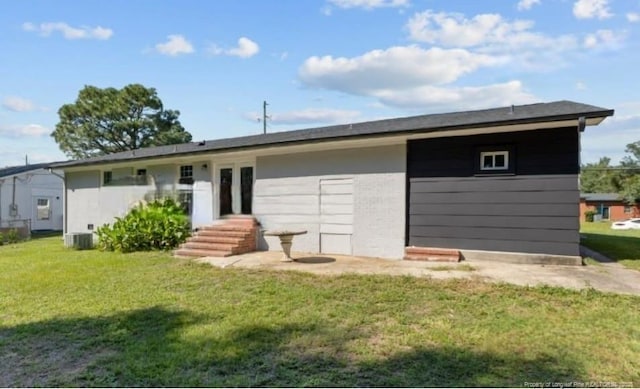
[580,222,640,270]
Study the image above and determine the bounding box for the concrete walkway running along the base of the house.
[196,251,640,295]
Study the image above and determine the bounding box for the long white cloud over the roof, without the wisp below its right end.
[299,46,502,95]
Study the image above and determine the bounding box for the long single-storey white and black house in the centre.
[54,101,613,261]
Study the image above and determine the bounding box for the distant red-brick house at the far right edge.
[580,193,640,221]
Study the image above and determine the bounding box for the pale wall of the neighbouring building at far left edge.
[0,169,64,230]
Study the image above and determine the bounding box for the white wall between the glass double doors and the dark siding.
[253,145,406,259]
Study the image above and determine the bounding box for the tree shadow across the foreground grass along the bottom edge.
[0,307,584,387]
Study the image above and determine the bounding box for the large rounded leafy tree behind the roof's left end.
[51,84,191,158]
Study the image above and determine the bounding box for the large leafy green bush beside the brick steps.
[96,198,191,253]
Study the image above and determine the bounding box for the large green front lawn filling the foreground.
[0,237,640,387]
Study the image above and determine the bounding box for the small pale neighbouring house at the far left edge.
[0,163,63,235]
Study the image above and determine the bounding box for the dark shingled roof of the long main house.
[52,100,613,167]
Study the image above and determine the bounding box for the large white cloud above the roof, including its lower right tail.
[299,46,536,112]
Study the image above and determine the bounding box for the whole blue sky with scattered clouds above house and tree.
[0,0,640,166]
